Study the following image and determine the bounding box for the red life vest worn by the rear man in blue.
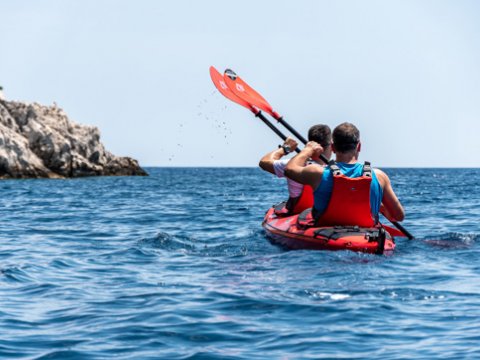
[316,161,377,227]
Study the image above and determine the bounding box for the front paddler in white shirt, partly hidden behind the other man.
[259,124,332,215]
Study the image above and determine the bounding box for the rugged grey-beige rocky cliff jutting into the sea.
[0,100,147,178]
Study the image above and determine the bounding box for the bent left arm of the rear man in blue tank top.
[285,141,323,190]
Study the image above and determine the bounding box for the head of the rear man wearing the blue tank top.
[332,122,362,163]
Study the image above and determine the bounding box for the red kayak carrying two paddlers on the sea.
[262,207,404,254]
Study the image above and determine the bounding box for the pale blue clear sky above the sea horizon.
[0,0,480,167]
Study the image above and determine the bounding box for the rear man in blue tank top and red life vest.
[285,122,405,227]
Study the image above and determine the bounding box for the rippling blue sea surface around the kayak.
[0,168,480,359]
